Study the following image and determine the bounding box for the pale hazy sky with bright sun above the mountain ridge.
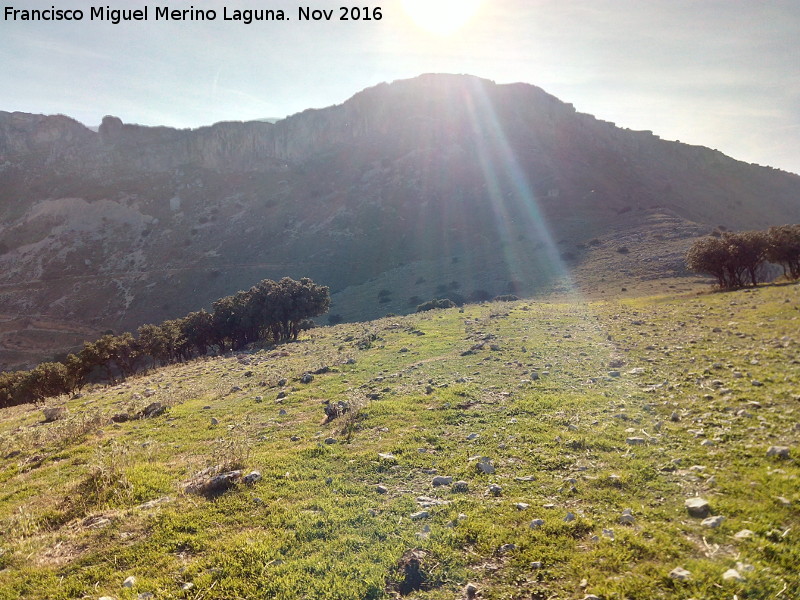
[0,0,800,173]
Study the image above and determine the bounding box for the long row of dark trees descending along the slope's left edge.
[0,277,330,408]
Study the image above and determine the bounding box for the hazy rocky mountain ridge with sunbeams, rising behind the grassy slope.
[0,75,800,367]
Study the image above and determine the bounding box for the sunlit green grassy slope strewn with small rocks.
[0,285,800,600]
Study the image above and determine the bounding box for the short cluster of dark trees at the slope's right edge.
[686,224,800,290]
